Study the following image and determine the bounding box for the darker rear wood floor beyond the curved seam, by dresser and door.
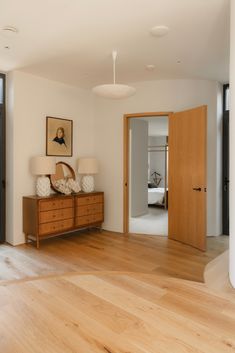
[0,231,228,282]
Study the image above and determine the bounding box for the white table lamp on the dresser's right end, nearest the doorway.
[78,158,98,192]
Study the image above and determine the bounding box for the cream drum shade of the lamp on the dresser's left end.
[30,156,56,175]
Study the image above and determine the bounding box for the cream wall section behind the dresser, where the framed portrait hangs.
[6,71,94,245]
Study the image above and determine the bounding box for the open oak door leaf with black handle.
[168,106,207,250]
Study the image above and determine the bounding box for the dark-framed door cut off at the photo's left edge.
[0,74,6,243]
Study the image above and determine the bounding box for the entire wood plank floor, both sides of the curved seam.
[0,232,232,353]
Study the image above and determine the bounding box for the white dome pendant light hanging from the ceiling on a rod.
[92,50,136,99]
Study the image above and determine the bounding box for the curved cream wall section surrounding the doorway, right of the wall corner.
[94,80,222,235]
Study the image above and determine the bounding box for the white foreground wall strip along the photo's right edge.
[229,1,235,288]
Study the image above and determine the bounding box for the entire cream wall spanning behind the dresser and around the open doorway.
[6,72,221,245]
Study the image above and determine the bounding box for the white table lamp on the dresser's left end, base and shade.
[30,156,56,197]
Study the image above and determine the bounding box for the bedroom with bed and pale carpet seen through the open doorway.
[129,115,168,236]
